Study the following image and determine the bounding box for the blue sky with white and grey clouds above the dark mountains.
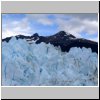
[2,13,98,41]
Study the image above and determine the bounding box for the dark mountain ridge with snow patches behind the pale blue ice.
[2,31,98,53]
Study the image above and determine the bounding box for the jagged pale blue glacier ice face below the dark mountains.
[2,37,98,86]
